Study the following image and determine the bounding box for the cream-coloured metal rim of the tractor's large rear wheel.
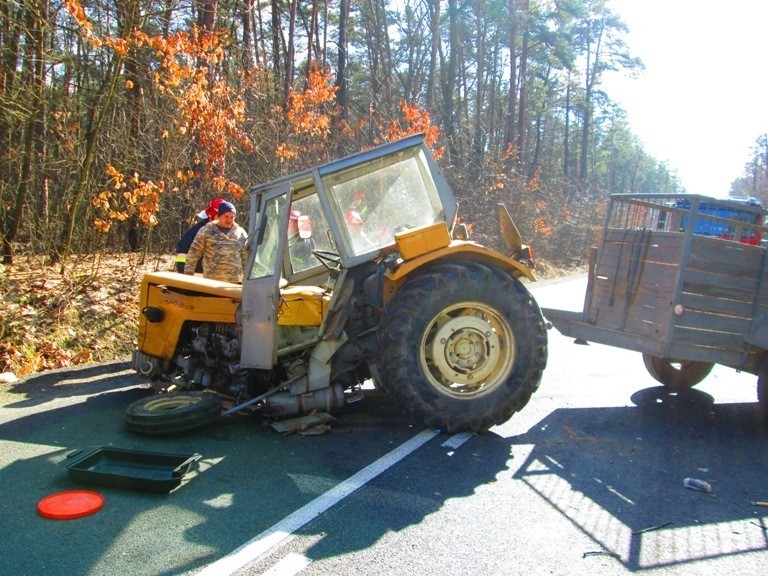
[420,302,515,399]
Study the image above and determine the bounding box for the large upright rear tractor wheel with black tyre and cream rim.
[378,262,547,432]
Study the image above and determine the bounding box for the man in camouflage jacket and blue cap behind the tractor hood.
[184,202,248,284]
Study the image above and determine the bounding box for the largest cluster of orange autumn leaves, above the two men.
[86,25,254,232]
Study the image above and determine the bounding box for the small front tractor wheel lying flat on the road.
[125,392,221,435]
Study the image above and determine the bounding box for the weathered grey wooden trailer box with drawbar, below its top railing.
[543,191,768,374]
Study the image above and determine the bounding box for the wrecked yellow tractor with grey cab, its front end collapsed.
[125,135,547,434]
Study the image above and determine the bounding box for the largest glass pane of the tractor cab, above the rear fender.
[322,146,445,256]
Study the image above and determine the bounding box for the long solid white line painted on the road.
[198,430,440,576]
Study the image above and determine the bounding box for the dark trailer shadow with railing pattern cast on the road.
[513,387,768,570]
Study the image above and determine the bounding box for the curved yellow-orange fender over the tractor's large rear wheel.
[383,240,536,305]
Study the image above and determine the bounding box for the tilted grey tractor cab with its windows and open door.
[241,136,457,368]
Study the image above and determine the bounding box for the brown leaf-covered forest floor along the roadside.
[0,253,570,383]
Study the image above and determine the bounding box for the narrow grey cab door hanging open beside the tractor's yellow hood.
[239,182,291,369]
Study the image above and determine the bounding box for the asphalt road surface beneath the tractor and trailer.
[0,280,768,576]
